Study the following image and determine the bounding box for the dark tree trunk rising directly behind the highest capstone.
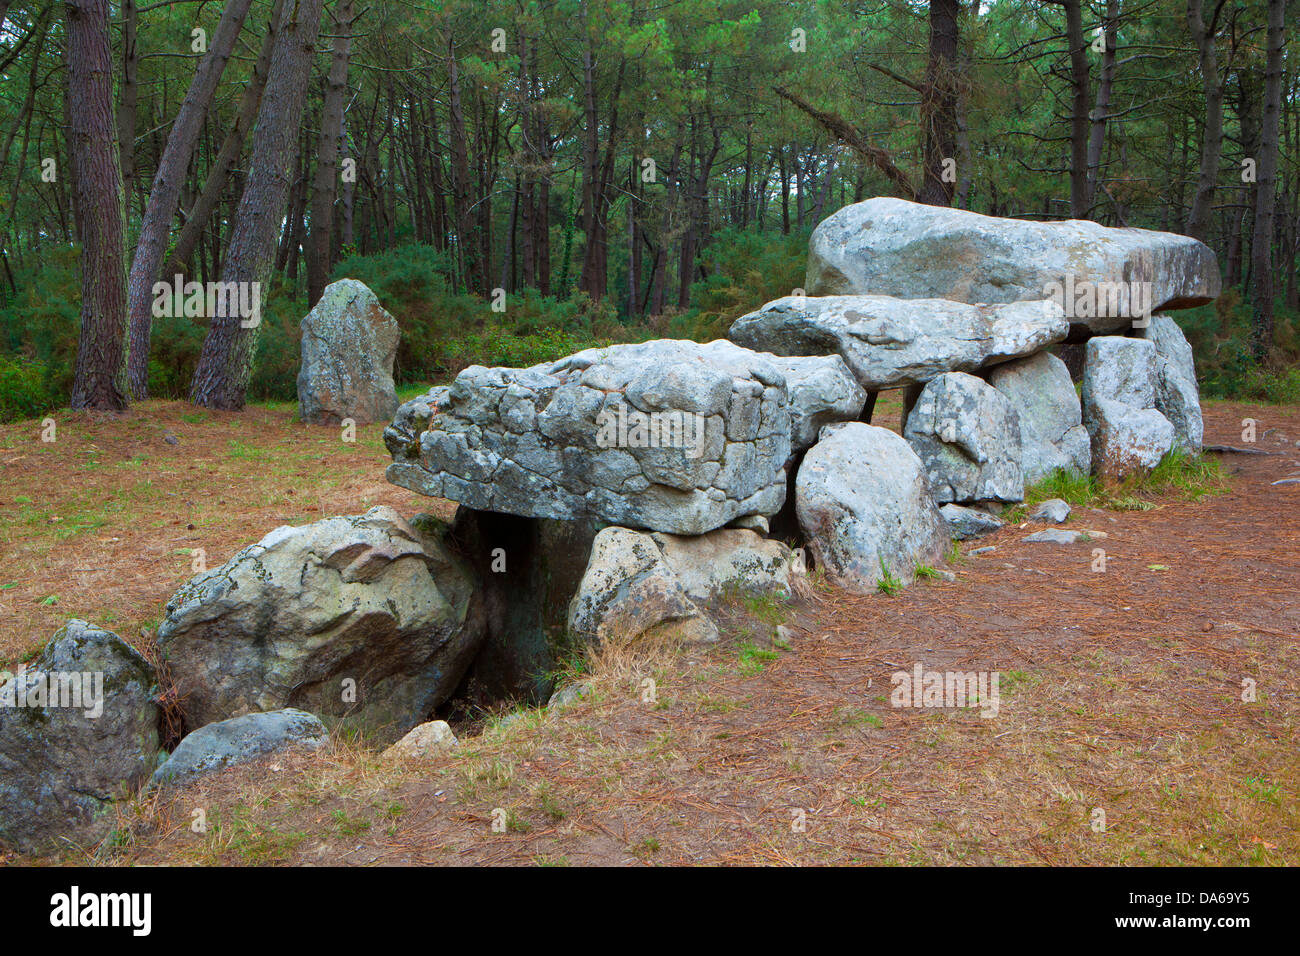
[917,0,962,206]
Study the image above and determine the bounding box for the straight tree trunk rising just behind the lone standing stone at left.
[307,0,354,307]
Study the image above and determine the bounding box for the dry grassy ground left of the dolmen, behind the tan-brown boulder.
[0,402,447,666]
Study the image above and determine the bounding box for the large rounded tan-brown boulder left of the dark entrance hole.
[159,506,484,740]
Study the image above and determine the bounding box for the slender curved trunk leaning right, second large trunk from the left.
[122,0,252,399]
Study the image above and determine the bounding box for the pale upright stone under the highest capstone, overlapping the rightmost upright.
[1083,336,1175,480]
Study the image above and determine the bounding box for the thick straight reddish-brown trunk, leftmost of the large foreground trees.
[66,0,127,410]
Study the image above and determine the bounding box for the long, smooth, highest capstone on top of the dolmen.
[803,198,1219,334]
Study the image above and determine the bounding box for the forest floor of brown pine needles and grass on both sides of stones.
[0,397,1300,865]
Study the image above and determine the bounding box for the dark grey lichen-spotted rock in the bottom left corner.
[0,620,165,853]
